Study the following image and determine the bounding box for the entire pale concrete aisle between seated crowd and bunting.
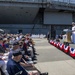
[34,39,75,75]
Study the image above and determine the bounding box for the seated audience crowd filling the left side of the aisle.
[0,34,40,75]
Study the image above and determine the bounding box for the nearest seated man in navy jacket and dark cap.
[7,51,39,75]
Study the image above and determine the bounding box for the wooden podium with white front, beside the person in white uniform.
[63,29,72,45]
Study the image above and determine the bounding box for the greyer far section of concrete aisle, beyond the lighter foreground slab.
[35,39,72,62]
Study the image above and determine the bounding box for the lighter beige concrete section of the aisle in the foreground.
[35,60,75,75]
